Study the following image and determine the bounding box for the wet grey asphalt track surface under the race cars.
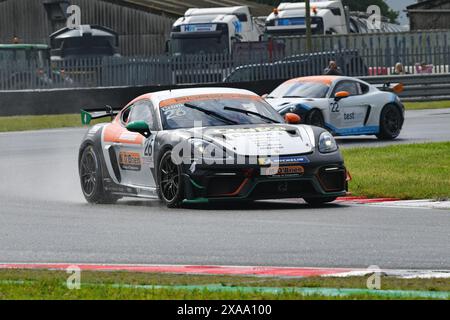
[0,110,450,269]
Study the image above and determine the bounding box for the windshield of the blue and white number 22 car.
[268,82,330,99]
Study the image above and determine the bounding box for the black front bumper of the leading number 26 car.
[183,152,347,202]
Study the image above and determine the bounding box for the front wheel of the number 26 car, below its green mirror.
[158,150,185,208]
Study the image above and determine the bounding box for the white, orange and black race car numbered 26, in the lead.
[78,88,348,207]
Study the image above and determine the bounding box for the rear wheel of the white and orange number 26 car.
[79,145,120,204]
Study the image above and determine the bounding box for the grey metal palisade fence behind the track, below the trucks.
[0,51,450,99]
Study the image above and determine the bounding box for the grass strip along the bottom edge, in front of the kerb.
[0,270,450,300]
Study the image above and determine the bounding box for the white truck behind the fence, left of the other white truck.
[167,6,264,56]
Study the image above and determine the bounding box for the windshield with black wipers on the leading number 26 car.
[160,96,283,130]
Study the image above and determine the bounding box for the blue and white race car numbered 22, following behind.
[266,76,405,139]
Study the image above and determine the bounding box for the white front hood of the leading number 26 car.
[174,124,315,156]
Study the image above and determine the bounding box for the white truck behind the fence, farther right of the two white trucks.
[265,0,405,37]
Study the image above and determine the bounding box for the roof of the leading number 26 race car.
[128,87,259,106]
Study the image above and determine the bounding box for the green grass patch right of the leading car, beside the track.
[342,142,450,199]
